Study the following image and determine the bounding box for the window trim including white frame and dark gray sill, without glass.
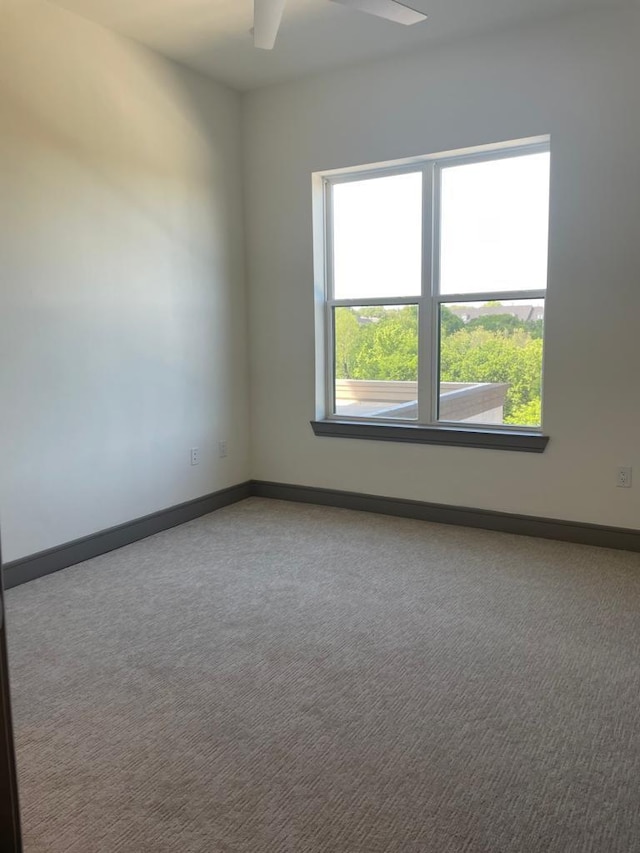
[311,135,550,452]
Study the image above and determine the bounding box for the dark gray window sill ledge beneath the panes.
[311,420,549,453]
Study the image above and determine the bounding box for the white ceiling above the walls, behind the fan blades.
[54,0,626,90]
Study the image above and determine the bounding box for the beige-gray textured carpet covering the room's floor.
[7,498,640,853]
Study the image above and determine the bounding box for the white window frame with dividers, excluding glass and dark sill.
[314,136,550,434]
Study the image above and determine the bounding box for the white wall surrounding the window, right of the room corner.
[244,12,640,528]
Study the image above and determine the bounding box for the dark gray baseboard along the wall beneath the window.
[251,480,640,551]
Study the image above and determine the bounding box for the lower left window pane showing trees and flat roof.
[333,305,418,420]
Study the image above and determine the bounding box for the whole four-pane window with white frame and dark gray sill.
[314,140,550,450]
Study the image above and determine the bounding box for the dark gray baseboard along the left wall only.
[3,482,252,589]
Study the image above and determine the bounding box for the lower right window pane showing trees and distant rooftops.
[438,299,544,427]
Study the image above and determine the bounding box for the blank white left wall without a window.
[0,0,249,561]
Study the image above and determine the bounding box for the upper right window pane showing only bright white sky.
[440,152,550,294]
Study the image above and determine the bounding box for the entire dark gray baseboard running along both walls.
[3,480,640,589]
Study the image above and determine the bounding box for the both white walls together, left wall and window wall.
[0,5,640,560]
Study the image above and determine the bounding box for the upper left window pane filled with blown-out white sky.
[333,172,422,299]
